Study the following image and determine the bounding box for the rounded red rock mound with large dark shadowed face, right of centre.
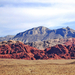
[45,44,69,59]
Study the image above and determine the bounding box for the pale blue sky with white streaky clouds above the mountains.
[0,0,75,37]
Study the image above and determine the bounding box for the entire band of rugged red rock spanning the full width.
[0,42,75,60]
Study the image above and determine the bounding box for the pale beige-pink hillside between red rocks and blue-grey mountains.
[25,38,75,50]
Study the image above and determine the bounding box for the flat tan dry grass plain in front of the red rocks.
[0,59,75,75]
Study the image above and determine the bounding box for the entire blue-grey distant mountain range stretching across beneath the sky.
[0,26,75,43]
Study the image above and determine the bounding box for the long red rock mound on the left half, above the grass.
[0,43,44,60]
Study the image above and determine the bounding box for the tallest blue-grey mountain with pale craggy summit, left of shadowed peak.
[13,26,51,42]
